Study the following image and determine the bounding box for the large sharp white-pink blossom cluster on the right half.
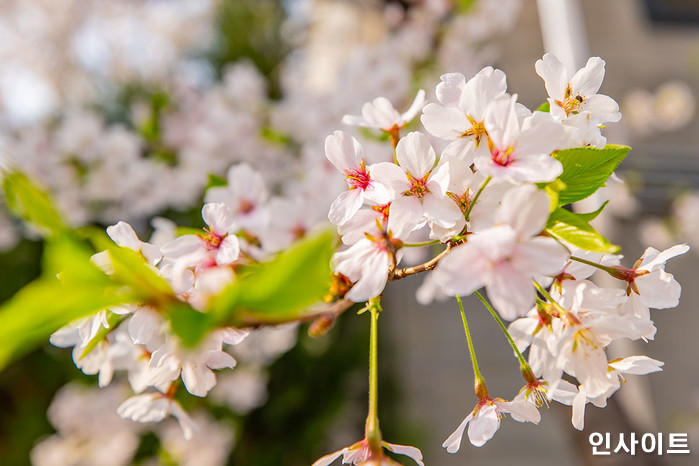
[326,54,689,456]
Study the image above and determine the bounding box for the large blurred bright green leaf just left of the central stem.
[211,231,335,324]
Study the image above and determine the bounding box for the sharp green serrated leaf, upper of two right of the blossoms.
[553,144,631,206]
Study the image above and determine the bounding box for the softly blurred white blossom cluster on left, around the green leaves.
[51,164,316,438]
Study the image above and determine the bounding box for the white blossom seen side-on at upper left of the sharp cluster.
[342,89,425,133]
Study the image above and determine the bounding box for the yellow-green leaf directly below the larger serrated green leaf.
[546,203,620,254]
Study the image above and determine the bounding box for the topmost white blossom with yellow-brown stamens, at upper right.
[535,53,621,123]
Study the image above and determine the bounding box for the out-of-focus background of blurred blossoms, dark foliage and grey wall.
[0,0,699,466]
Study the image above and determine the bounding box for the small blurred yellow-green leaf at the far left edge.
[2,171,68,236]
